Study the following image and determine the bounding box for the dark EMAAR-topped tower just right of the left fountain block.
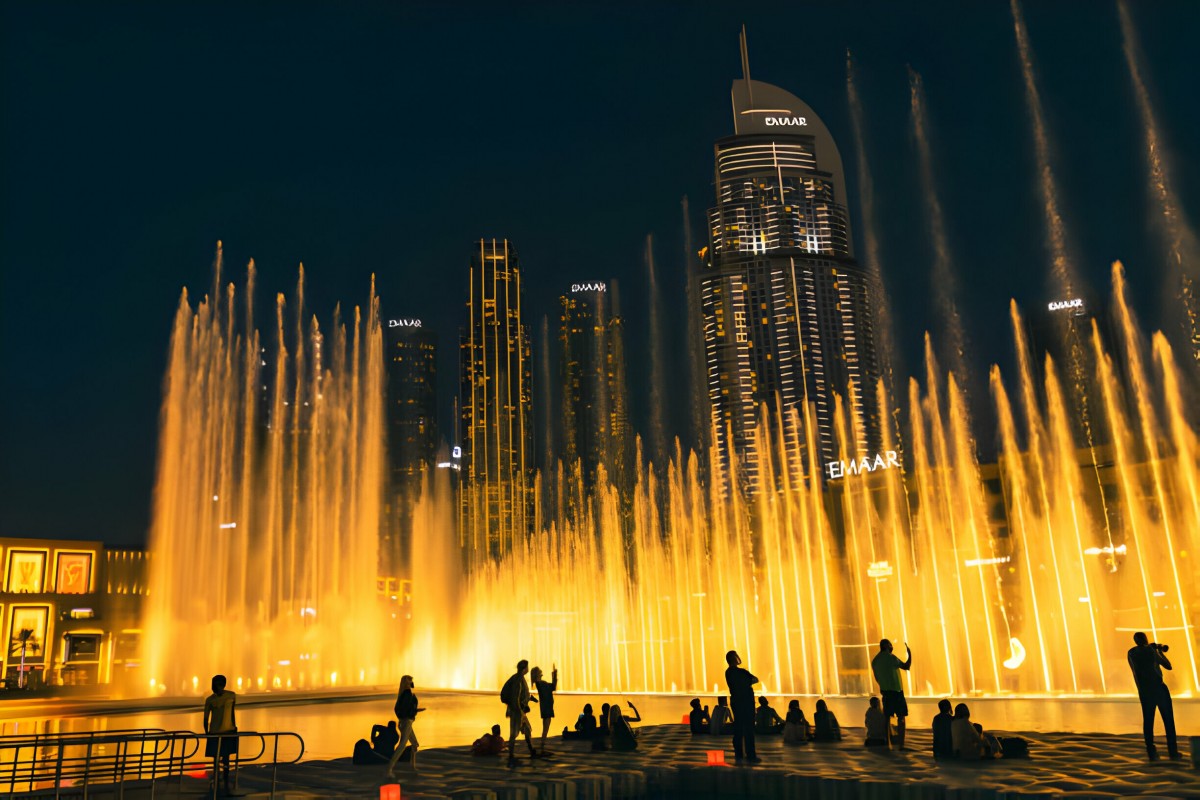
[379,318,438,576]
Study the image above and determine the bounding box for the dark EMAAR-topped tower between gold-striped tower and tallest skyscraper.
[558,281,631,489]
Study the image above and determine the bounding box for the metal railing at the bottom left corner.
[0,728,305,800]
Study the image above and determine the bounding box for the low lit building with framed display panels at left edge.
[0,539,146,688]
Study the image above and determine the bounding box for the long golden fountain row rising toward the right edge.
[409,266,1200,694]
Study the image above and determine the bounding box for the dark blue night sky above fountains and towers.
[0,0,1200,543]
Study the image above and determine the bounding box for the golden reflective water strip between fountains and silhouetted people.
[0,692,1180,760]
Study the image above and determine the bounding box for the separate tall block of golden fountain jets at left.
[144,249,391,693]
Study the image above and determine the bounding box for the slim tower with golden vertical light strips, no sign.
[458,239,534,559]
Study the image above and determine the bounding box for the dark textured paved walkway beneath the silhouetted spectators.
[218,724,1200,800]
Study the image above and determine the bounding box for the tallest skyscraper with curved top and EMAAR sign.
[697,61,881,492]
